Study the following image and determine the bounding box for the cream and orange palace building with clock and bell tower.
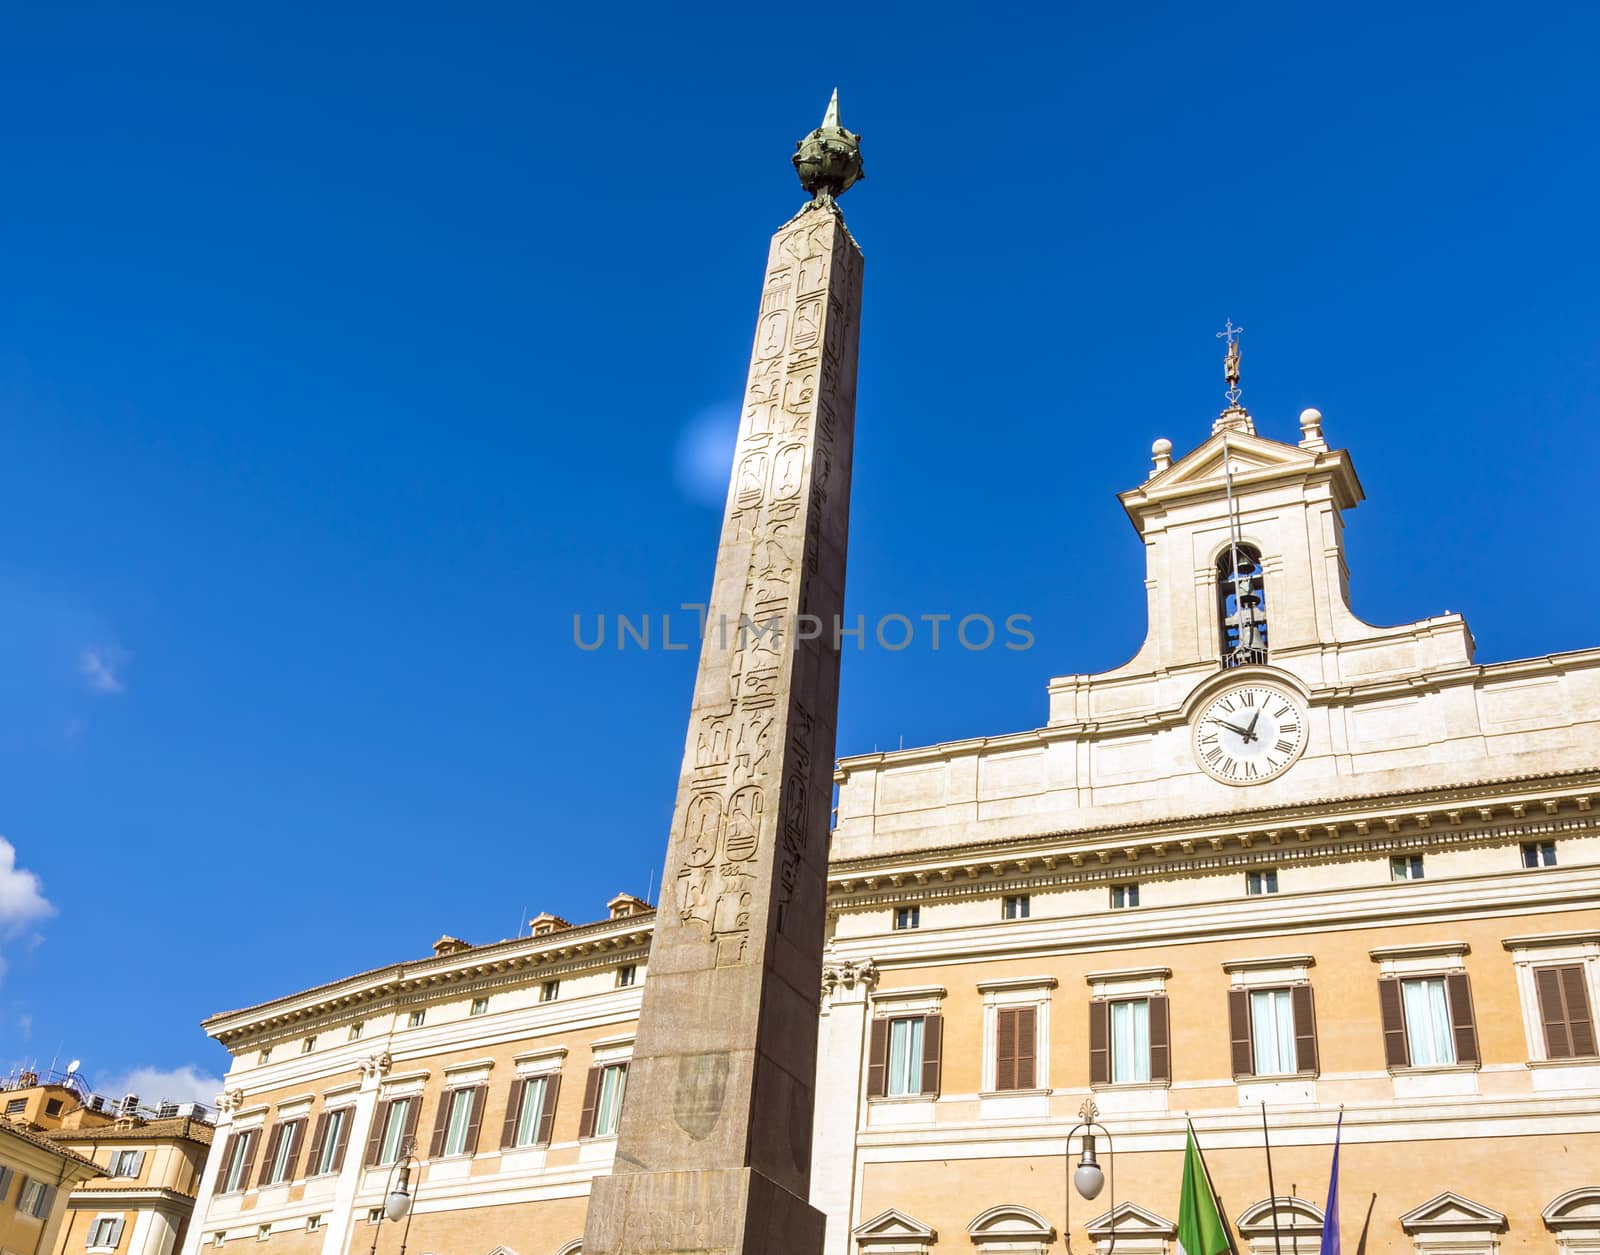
[172,388,1600,1255]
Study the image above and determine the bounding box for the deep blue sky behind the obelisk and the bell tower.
[0,5,1600,1097]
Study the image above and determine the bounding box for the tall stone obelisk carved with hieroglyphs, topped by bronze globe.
[584,91,862,1255]
